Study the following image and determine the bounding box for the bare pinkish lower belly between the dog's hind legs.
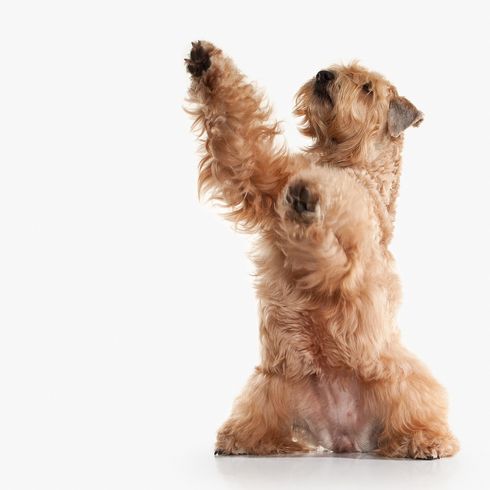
[299,376,377,452]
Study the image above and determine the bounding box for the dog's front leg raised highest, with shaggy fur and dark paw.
[186,41,289,229]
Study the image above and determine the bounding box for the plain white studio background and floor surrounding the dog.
[0,0,490,490]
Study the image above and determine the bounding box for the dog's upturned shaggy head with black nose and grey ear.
[295,63,423,166]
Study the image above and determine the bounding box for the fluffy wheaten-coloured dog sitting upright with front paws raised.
[186,42,458,459]
